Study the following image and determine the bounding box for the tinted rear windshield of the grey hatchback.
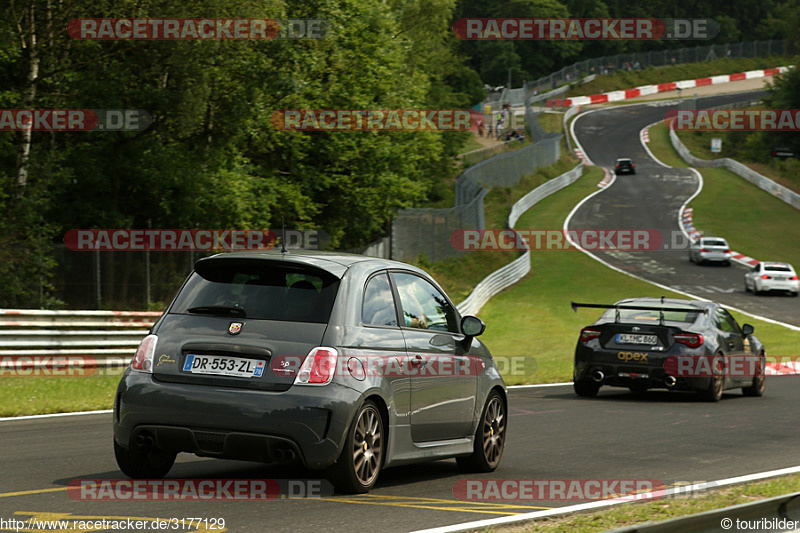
[170,260,339,323]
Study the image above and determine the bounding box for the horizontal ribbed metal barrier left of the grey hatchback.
[0,309,161,366]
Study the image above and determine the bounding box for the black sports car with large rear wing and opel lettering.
[572,297,766,402]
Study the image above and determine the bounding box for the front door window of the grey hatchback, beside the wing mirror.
[392,272,459,333]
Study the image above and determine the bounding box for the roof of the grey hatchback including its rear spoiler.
[200,250,419,278]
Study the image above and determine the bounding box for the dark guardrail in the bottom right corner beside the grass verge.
[612,492,800,533]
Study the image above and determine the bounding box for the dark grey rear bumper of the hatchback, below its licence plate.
[114,371,360,468]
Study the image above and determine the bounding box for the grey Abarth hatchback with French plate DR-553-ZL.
[113,251,508,493]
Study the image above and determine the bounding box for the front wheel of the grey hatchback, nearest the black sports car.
[456,390,508,472]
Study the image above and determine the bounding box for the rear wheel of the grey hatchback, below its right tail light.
[330,400,386,494]
